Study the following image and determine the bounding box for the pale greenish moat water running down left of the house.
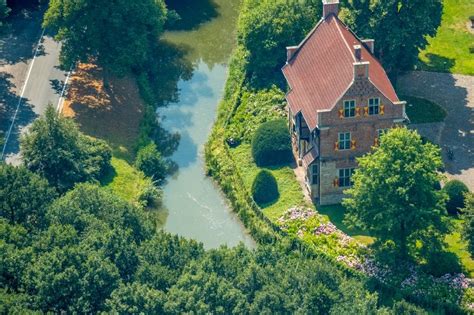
[158,0,254,248]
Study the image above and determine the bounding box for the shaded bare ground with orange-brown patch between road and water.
[62,64,144,161]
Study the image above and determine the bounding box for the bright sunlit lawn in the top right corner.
[419,0,474,75]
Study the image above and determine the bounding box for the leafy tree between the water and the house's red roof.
[238,0,321,85]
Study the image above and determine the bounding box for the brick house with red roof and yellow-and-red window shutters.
[282,0,406,205]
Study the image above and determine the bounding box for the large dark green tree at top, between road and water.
[43,0,167,79]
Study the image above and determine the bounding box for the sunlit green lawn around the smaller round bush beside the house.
[230,144,311,222]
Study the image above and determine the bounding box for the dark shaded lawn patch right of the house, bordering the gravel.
[400,95,447,124]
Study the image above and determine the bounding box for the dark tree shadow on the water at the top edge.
[166,0,218,31]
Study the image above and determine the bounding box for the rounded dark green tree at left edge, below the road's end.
[0,164,56,230]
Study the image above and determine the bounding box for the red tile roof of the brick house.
[283,15,399,130]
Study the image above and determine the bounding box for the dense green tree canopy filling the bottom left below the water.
[0,179,420,314]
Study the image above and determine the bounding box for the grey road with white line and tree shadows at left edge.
[0,7,67,165]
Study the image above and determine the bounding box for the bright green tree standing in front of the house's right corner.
[343,128,446,258]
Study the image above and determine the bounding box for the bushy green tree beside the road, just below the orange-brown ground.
[21,106,112,191]
